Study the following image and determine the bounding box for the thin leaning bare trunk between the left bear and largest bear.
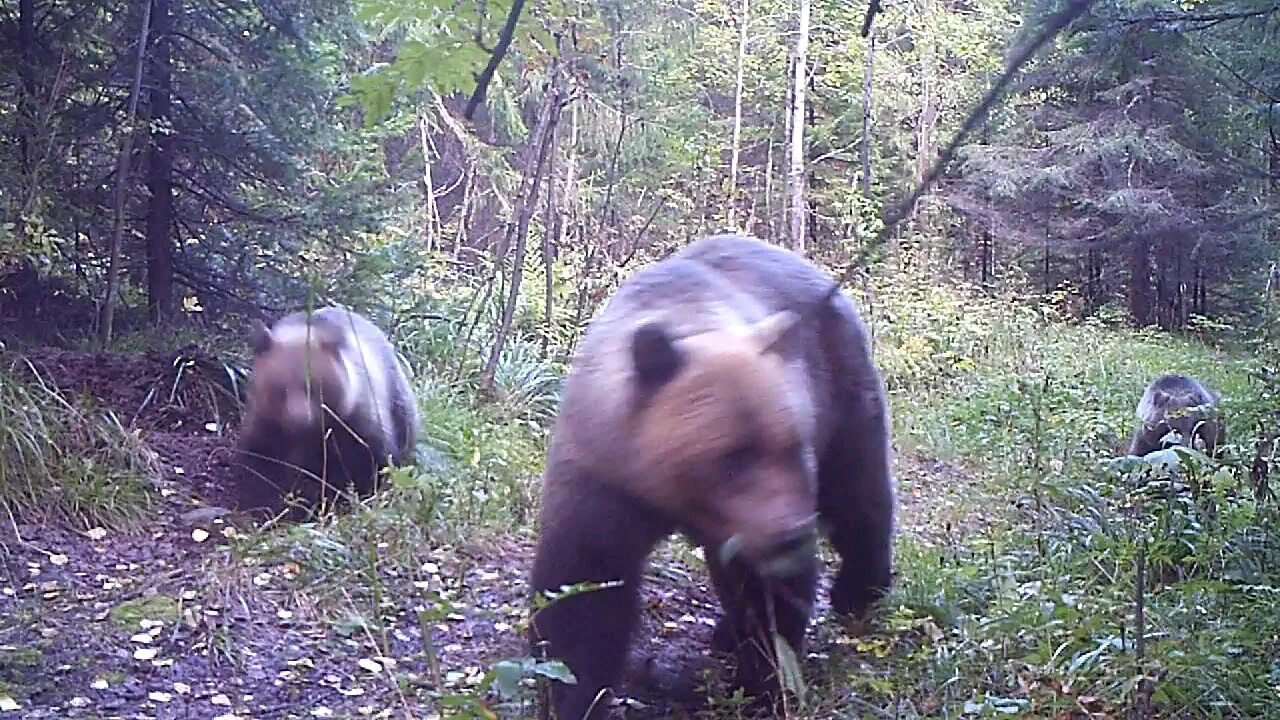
[480,54,564,396]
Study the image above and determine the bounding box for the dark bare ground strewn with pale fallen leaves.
[0,350,1007,719]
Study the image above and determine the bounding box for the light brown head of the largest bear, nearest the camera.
[630,313,817,574]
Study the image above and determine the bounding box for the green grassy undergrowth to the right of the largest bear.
[849,260,1280,717]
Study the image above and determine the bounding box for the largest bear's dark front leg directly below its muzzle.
[707,552,818,705]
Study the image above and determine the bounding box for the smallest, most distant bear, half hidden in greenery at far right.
[1129,374,1225,456]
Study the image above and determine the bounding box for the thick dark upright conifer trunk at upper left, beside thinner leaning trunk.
[147,0,178,324]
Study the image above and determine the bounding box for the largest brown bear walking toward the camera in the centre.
[530,234,893,720]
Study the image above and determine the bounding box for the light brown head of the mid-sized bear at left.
[248,316,352,437]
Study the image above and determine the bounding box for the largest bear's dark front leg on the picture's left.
[530,470,671,720]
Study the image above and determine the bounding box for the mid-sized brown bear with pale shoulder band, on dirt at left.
[239,307,417,510]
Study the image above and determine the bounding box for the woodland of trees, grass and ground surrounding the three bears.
[0,0,1280,719]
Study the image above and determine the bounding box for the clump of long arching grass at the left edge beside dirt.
[0,361,156,529]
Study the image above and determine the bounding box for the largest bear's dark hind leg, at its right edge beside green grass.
[818,383,893,615]
